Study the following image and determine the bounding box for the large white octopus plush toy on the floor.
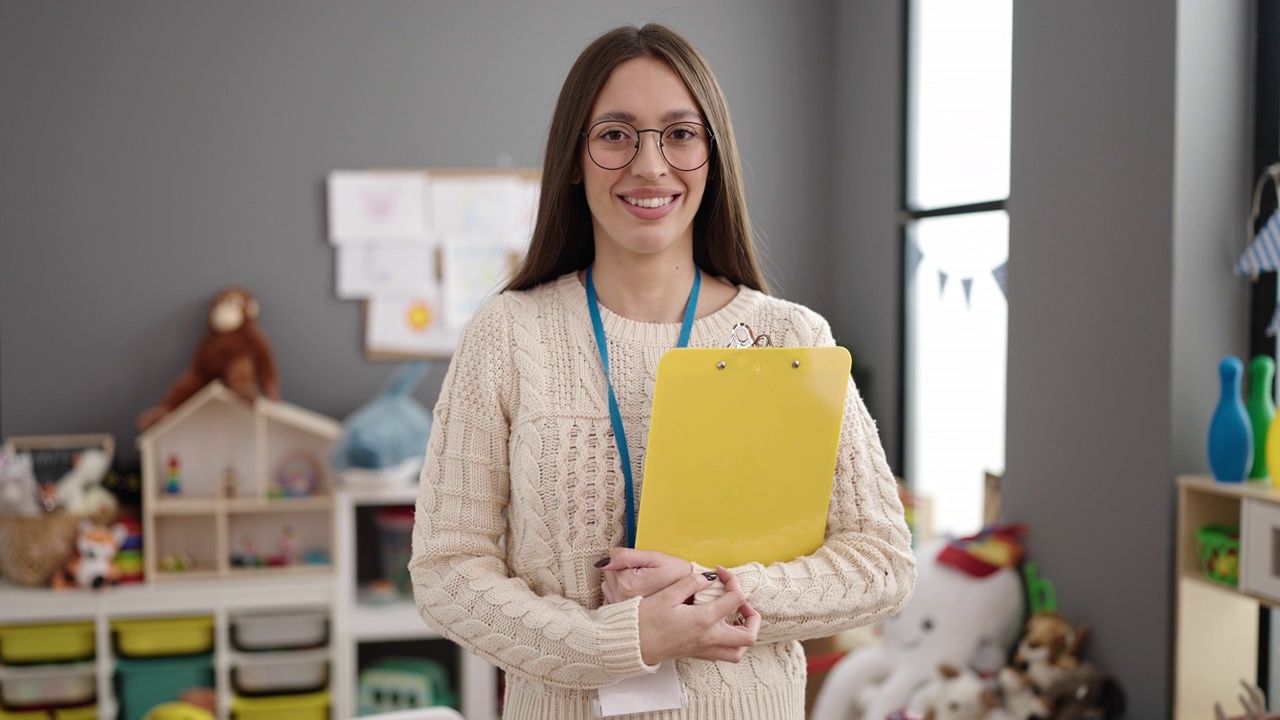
[810,538,1023,720]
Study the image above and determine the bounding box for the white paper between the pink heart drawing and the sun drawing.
[337,241,439,300]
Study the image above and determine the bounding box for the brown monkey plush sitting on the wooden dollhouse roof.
[138,286,280,430]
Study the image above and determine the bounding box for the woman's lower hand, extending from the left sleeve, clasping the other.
[640,568,760,665]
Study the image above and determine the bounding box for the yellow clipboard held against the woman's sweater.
[636,347,851,568]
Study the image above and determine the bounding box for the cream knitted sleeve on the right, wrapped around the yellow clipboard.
[698,311,915,642]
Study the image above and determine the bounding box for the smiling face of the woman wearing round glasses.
[579,58,710,261]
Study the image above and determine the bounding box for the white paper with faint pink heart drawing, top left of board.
[328,170,431,245]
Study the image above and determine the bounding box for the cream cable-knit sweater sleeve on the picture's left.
[410,296,657,689]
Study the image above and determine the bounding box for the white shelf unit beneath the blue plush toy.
[332,483,498,720]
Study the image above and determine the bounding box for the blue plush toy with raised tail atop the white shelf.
[330,361,431,473]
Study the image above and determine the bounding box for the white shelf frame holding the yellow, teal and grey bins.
[0,575,335,720]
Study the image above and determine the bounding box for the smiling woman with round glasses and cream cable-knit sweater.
[410,24,915,720]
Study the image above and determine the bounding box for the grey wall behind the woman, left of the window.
[0,0,833,461]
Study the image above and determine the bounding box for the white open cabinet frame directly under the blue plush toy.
[333,475,499,720]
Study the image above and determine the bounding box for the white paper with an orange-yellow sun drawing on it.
[365,293,458,357]
